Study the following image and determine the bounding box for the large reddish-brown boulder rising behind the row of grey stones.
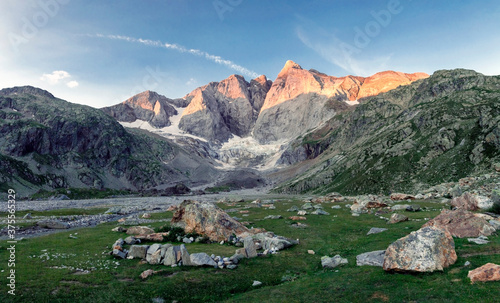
[172,200,250,241]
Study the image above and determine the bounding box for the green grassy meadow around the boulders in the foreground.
[0,200,500,303]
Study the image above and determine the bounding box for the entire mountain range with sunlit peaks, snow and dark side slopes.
[0,61,500,198]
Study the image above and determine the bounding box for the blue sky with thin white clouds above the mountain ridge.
[0,0,500,107]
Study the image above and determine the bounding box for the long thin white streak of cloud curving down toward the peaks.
[89,34,259,78]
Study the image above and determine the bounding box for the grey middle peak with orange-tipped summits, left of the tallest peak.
[179,75,270,141]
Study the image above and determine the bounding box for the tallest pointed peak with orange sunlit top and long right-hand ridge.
[253,61,428,143]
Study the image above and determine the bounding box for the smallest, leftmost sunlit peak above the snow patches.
[102,90,178,128]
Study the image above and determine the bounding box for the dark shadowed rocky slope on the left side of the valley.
[0,87,219,196]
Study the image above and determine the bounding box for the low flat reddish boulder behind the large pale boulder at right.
[422,209,495,238]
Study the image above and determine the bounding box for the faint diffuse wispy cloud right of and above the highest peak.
[296,18,392,76]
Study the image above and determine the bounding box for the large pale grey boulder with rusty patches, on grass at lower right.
[383,227,457,272]
